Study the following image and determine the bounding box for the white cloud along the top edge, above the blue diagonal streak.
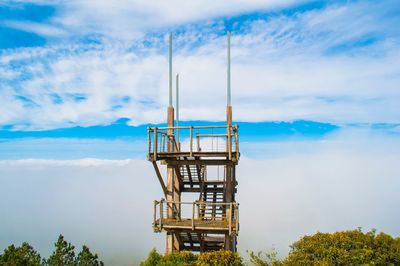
[50,0,307,38]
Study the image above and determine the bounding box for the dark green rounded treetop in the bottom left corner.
[0,242,42,266]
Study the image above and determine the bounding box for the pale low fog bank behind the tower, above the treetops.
[0,132,400,265]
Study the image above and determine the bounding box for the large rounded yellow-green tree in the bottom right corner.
[283,229,400,265]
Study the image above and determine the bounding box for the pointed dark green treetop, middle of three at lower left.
[47,235,76,266]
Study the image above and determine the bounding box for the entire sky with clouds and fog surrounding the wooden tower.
[0,0,400,265]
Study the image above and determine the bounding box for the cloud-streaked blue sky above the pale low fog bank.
[0,0,400,157]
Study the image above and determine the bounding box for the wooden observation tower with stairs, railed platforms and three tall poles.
[148,33,240,254]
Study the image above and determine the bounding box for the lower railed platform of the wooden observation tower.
[153,199,239,235]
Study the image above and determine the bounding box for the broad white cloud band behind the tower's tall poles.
[0,2,400,129]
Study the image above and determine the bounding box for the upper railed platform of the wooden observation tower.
[147,125,240,164]
